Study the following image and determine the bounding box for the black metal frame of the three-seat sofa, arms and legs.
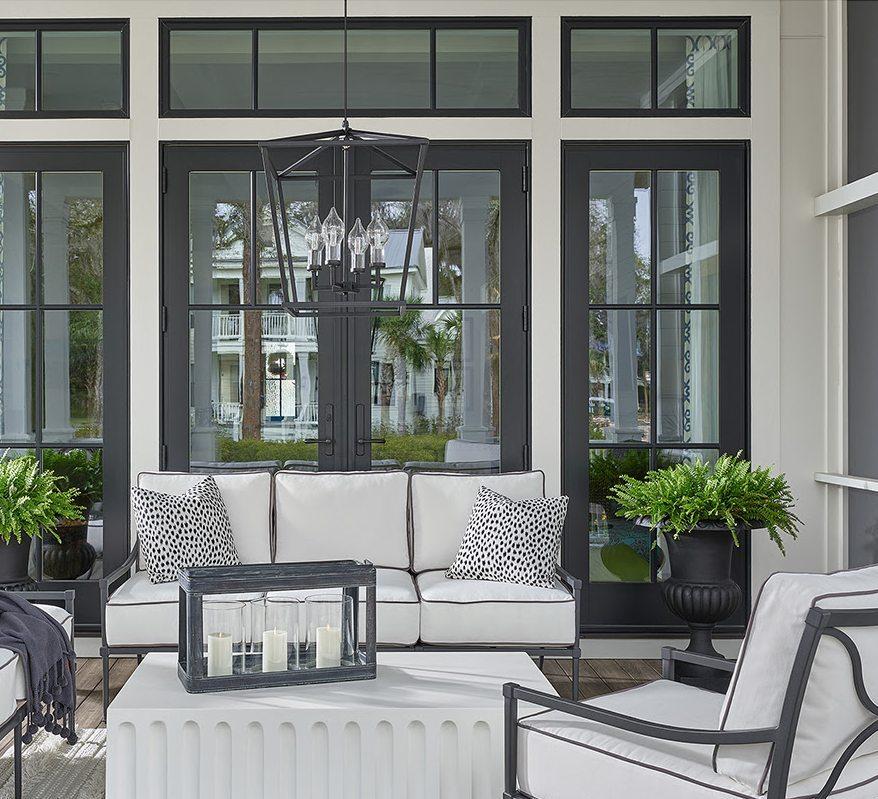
[100,541,582,721]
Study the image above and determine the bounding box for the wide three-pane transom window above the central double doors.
[161,18,530,116]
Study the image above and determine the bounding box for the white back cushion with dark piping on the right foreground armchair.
[715,566,878,794]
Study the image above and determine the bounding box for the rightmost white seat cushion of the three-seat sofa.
[416,571,576,646]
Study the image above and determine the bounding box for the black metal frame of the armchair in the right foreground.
[503,608,878,799]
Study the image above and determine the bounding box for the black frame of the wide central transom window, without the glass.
[159,17,531,118]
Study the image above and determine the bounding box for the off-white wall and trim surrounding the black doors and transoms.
[0,0,844,644]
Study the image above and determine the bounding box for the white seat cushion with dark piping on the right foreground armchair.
[518,680,878,799]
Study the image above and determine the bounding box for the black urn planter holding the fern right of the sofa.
[662,525,743,657]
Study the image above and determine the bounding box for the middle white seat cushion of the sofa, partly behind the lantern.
[268,569,421,646]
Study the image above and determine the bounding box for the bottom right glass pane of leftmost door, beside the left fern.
[42,449,104,580]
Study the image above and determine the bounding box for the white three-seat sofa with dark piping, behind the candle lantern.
[101,471,579,708]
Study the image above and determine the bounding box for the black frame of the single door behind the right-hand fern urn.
[561,140,751,638]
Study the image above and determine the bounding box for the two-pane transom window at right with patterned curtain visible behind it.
[561,17,750,116]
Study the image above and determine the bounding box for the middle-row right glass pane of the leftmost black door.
[43,311,104,442]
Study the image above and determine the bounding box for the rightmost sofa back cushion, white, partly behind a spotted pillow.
[411,471,546,572]
